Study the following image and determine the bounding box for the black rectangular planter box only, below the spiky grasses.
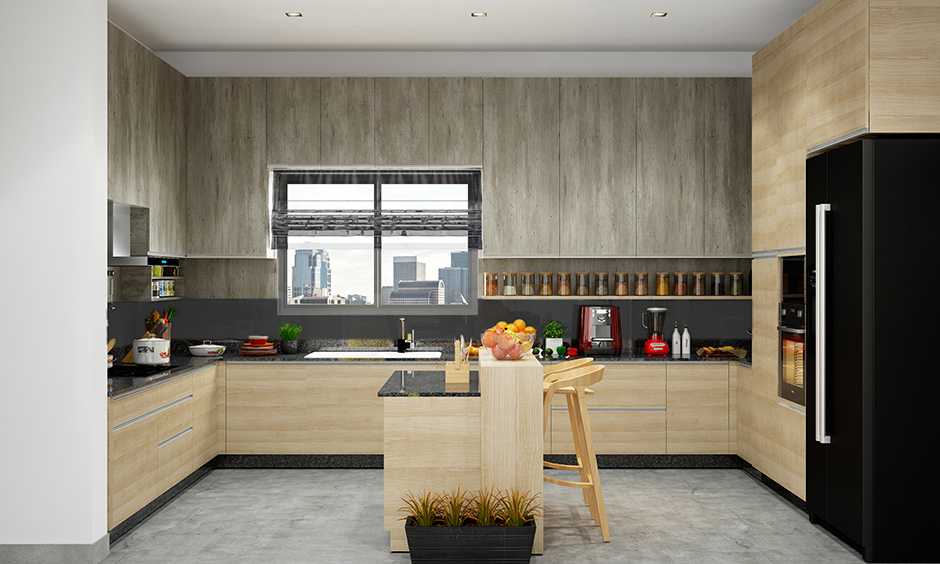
[405,522,536,564]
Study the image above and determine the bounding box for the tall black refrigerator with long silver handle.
[805,136,940,562]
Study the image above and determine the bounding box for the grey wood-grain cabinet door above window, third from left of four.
[375,77,429,165]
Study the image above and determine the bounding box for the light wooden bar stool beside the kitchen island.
[542,365,610,542]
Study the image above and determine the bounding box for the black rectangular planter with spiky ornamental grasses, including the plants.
[401,488,542,564]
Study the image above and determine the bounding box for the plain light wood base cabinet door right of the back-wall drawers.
[666,363,729,454]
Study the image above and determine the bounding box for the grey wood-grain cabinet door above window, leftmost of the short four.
[265,77,320,165]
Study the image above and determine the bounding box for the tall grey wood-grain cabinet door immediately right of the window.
[483,78,561,255]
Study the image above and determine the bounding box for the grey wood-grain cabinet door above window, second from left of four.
[320,77,375,165]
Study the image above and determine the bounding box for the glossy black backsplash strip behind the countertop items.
[108,298,751,346]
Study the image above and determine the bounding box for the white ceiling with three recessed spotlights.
[108,0,819,75]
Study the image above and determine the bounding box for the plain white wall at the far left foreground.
[0,0,107,548]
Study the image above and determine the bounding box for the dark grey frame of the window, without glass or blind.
[270,167,482,316]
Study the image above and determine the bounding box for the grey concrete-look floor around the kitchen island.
[104,470,862,564]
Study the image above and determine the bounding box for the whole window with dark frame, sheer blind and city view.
[271,170,481,315]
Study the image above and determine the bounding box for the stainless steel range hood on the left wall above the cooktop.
[108,201,179,266]
